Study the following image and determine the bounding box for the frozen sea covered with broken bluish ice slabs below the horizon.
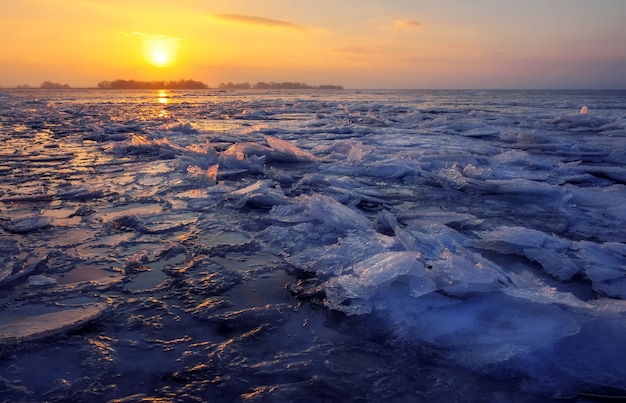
[0,90,626,402]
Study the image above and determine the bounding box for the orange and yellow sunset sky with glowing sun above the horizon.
[0,0,626,89]
